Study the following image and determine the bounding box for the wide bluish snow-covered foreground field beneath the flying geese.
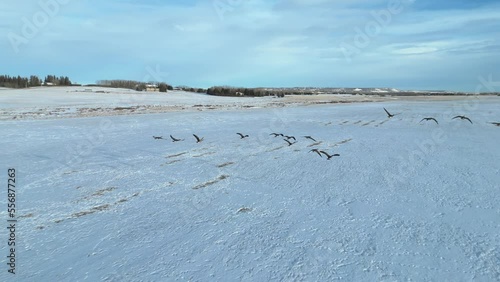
[0,93,500,281]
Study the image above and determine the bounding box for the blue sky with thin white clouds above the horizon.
[0,0,500,91]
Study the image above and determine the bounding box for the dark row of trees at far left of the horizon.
[0,75,72,88]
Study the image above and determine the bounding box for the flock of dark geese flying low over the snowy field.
[153,108,500,160]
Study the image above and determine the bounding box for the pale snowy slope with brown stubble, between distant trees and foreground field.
[0,87,463,120]
